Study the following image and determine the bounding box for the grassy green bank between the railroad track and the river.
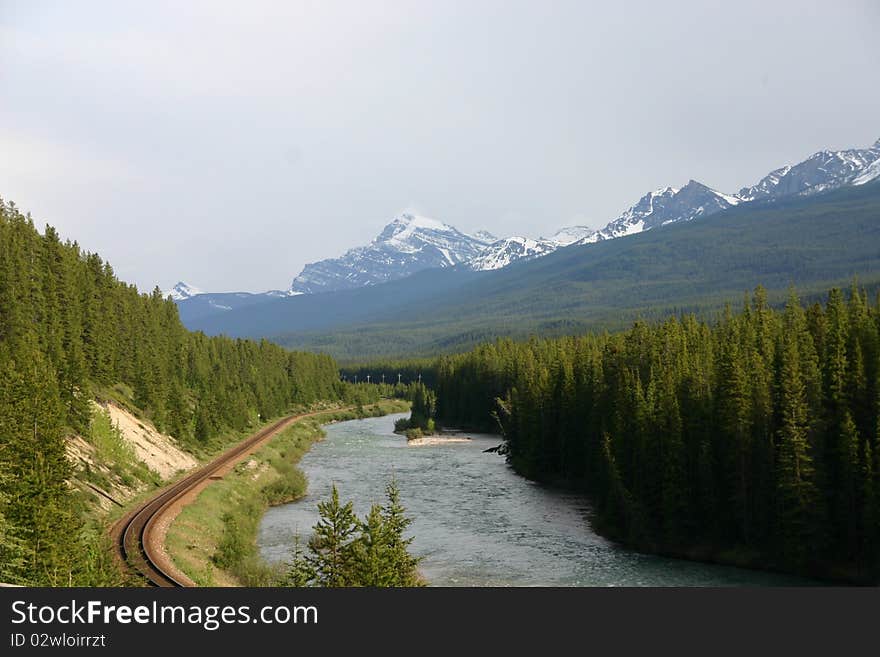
[166,400,409,586]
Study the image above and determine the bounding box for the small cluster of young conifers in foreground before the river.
[285,481,421,587]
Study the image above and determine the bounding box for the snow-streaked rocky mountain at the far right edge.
[738,139,880,201]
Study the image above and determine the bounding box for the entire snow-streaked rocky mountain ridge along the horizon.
[169,133,880,313]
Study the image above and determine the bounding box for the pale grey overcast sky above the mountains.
[0,0,880,291]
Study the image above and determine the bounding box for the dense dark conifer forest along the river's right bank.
[437,287,880,582]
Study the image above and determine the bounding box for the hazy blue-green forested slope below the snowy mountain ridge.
[184,182,880,362]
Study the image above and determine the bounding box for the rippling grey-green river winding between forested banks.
[258,414,811,586]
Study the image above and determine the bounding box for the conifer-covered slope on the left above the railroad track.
[0,201,342,585]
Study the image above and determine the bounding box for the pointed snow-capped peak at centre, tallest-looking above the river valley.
[290,213,492,294]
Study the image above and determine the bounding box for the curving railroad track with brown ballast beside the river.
[110,409,345,587]
